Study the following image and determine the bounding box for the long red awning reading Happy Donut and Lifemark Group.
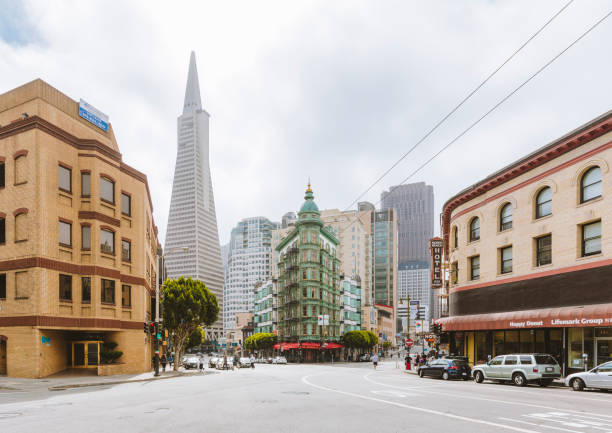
[436,304,612,331]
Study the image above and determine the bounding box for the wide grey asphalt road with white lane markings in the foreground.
[0,362,612,433]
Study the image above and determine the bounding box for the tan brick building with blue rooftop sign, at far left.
[0,80,159,377]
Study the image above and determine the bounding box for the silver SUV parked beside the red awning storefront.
[472,353,561,386]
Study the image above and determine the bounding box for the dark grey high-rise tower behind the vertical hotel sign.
[381,182,434,264]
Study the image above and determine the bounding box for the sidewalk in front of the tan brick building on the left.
[0,369,213,392]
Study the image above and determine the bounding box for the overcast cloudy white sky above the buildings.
[0,0,612,243]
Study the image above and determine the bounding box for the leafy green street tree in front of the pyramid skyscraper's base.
[162,277,219,371]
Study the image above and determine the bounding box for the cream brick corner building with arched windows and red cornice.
[441,112,612,373]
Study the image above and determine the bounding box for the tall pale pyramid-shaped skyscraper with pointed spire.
[164,51,224,341]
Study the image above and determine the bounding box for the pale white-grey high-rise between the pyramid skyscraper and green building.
[223,217,279,330]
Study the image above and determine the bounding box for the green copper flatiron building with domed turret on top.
[276,184,343,352]
